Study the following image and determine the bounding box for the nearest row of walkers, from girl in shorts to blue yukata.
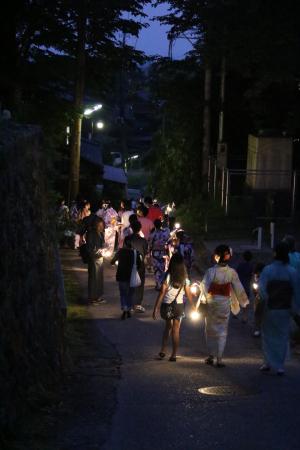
[153,236,300,376]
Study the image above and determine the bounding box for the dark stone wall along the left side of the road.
[0,122,63,434]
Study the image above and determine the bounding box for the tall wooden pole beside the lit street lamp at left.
[69,0,87,202]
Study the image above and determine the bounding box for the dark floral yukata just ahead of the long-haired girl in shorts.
[148,229,169,289]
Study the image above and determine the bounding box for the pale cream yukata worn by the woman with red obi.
[201,264,249,359]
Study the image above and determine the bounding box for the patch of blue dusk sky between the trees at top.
[126,3,191,59]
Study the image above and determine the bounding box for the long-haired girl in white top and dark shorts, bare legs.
[152,254,194,362]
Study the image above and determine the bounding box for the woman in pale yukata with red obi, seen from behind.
[201,245,249,367]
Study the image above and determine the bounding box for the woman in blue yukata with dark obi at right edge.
[259,242,300,375]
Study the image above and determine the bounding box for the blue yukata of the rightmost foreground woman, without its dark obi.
[259,261,300,370]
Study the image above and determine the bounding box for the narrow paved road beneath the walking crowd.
[68,251,300,450]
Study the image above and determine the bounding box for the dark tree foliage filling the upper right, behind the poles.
[149,0,300,203]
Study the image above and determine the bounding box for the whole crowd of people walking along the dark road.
[57,198,300,375]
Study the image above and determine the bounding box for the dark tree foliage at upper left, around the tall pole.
[0,0,148,197]
